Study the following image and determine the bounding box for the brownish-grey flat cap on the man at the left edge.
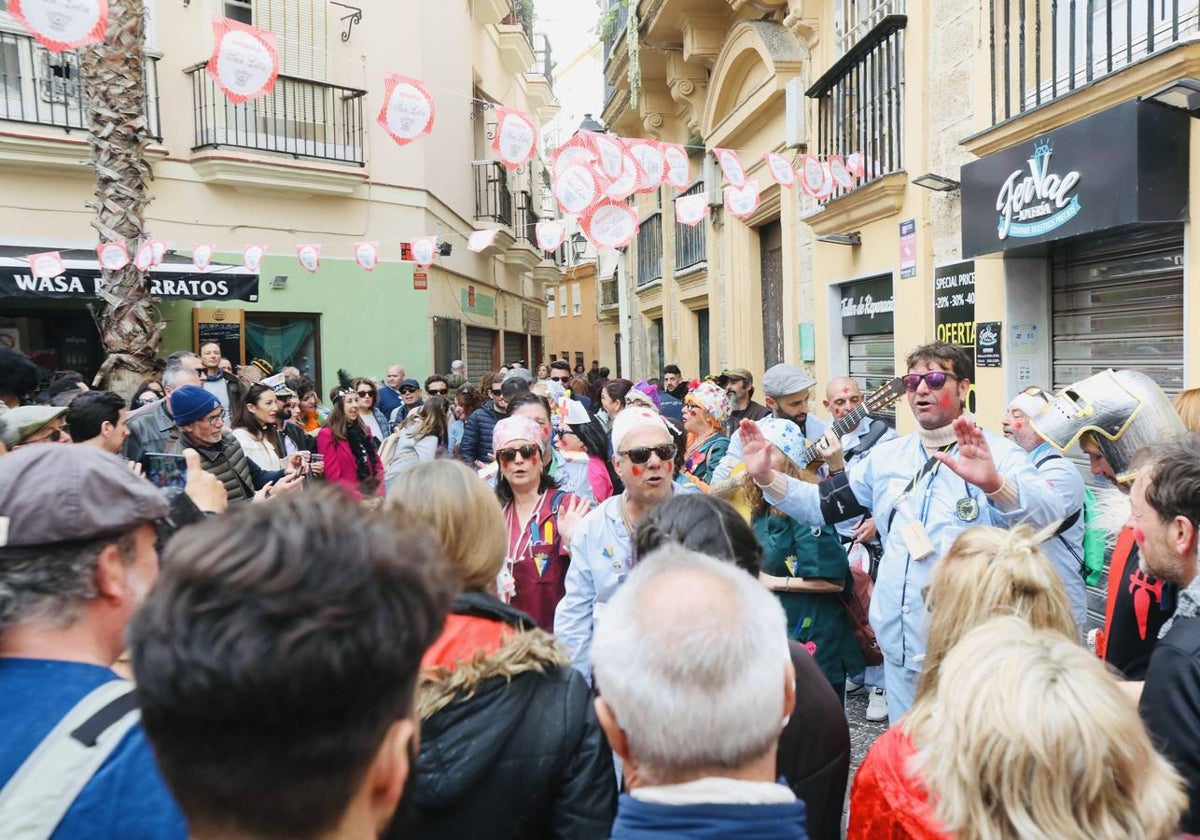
[0,444,168,559]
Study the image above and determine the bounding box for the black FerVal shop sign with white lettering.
[961,102,1189,257]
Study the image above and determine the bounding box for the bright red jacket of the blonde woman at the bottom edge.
[846,726,953,840]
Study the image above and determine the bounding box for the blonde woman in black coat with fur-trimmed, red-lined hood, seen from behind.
[384,458,617,840]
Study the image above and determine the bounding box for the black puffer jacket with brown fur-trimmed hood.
[389,593,617,840]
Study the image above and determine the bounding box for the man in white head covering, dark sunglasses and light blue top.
[554,406,685,677]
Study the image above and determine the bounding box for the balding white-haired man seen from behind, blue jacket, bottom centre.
[592,546,808,840]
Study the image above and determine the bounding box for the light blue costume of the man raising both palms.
[766,431,1063,671]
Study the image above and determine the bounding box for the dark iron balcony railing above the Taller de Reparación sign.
[808,14,908,200]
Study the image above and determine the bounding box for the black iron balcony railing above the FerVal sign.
[988,0,1200,125]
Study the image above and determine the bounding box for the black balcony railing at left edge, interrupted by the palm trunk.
[0,32,162,140]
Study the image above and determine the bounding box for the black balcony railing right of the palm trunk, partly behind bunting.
[184,61,366,166]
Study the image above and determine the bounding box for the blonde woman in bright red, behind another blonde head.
[846,526,1084,840]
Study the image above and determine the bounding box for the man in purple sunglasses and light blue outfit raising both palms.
[742,342,1063,725]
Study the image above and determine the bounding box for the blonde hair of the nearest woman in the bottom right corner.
[912,616,1187,840]
